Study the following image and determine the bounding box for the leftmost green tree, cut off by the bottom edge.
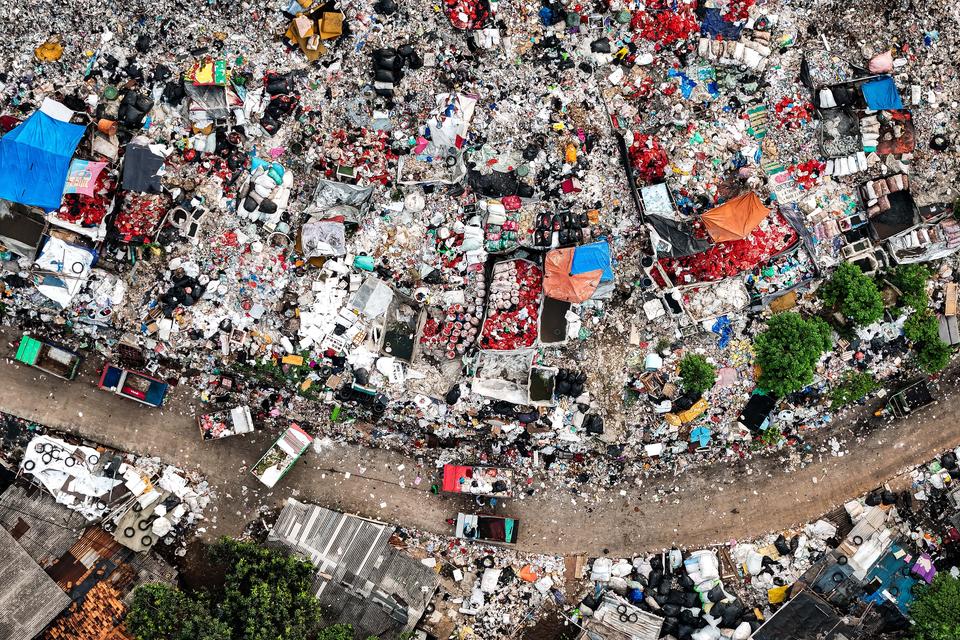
[126,584,230,640]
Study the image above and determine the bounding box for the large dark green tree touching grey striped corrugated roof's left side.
[210,538,321,640]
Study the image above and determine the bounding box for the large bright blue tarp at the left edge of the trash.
[0,111,86,211]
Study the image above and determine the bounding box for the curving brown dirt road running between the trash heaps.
[0,334,960,555]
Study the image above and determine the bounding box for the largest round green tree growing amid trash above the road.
[753,312,833,397]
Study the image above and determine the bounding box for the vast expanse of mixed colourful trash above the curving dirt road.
[0,0,960,556]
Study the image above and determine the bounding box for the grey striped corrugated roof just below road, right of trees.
[269,499,438,638]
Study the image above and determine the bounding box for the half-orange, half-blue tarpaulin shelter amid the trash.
[543,241,613,303]
